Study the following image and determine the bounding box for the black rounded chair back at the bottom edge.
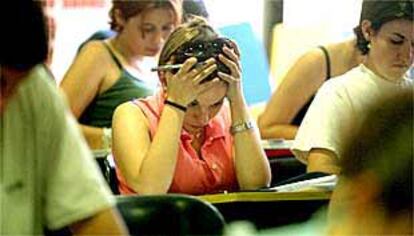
[116,194,225,235]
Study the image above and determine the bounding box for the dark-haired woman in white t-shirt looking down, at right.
[293,0,414,173]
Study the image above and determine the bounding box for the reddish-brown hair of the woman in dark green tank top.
[109,0,182,32]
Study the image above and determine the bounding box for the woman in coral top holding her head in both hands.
[113,17,271,195]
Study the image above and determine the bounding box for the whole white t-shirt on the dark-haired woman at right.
[292,64,413,163]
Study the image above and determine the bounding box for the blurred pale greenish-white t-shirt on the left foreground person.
[0,65,114,235]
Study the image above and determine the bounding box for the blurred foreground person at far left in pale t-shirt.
[0,0,126,235]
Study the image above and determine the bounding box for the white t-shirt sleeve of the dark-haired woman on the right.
[292,80,353,163]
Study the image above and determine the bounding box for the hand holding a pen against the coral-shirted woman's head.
[166,57,220,106]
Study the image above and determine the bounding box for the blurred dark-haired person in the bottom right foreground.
[225,89,414,236]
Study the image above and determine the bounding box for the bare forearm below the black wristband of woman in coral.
[133,105,185,194]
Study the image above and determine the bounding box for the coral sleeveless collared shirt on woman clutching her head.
[117,93,239,195]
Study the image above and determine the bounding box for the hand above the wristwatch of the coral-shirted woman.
[217,41,243,102]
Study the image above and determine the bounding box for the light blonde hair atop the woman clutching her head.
[158,16,219,65]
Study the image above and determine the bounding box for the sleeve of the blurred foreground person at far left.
[31,67,114,229]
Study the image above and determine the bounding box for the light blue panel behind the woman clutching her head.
[219,23,271,105]
